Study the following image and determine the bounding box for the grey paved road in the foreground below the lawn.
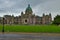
[0,34,60,40]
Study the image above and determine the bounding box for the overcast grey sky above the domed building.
[0,0,60,17]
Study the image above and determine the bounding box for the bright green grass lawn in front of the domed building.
[0,25,60,33]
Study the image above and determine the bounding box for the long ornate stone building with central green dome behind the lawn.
[0,5,52,24]
